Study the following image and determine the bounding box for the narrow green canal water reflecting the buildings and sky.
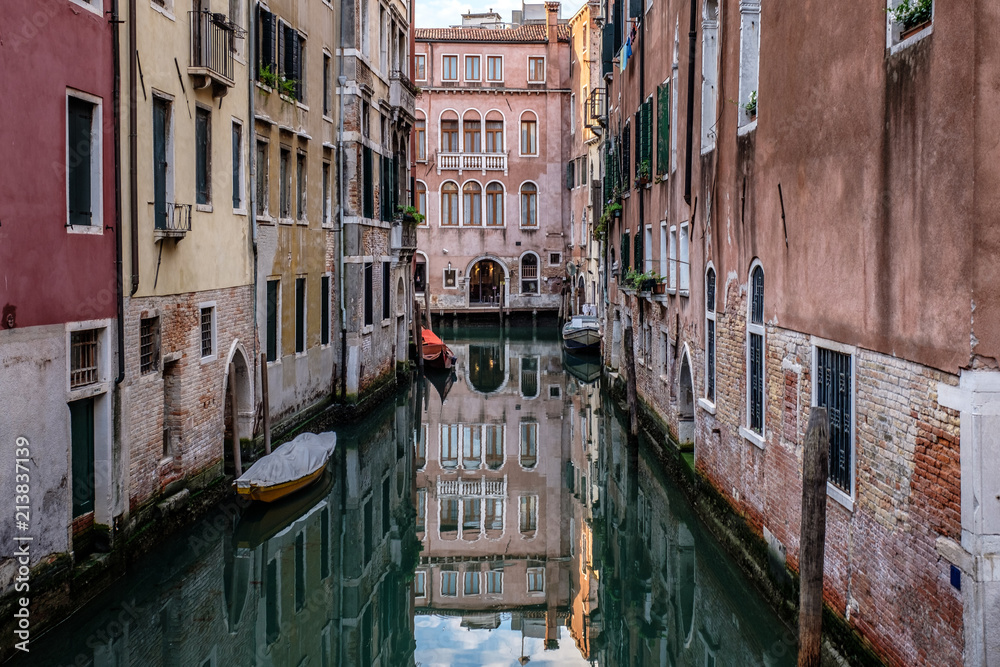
[15,329,794,667]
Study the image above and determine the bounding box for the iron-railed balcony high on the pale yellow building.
[188,11,239,97]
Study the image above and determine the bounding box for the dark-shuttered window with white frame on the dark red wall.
[66,97,102,228]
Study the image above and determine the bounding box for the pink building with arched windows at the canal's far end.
[414,3,570,312]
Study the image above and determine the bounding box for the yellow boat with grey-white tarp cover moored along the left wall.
[236,432,337,503]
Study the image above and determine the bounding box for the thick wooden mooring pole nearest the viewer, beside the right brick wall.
[798,407,830,667]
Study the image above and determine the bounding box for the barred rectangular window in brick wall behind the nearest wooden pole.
[815,347,854,496]
